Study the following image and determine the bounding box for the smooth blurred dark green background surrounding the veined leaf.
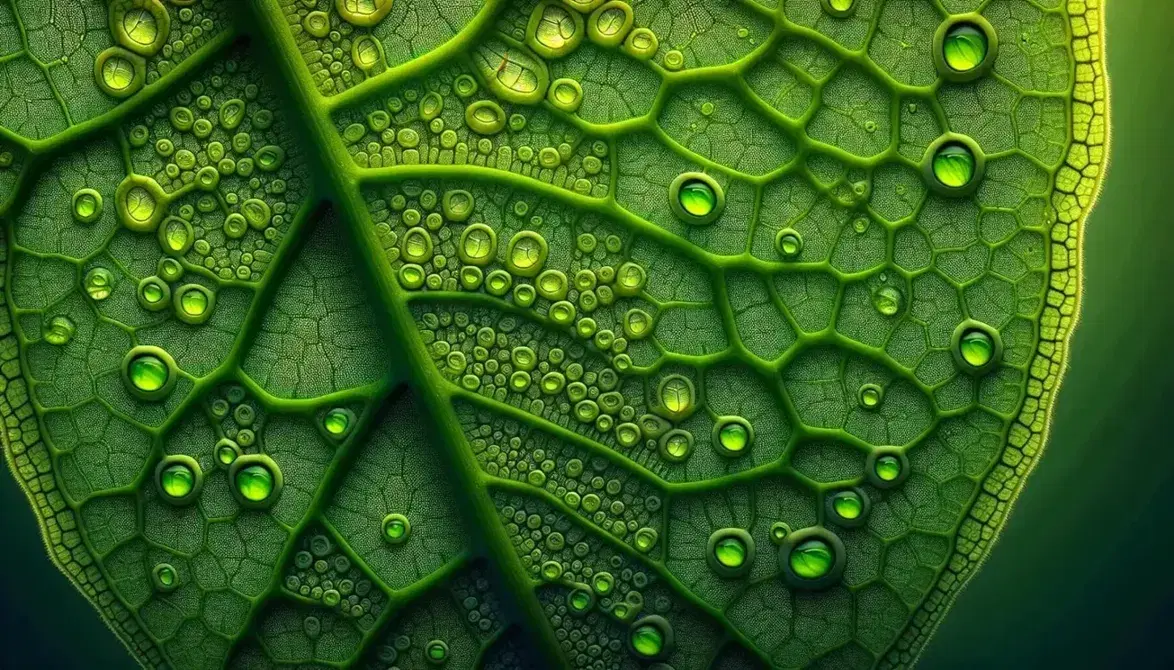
[0,0,1174,669]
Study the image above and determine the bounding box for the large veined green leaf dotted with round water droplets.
[0,0,1108,670]
